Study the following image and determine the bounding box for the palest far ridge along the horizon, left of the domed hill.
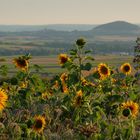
[0,24,97,32]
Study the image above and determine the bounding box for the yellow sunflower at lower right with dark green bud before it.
[122,101,139,117]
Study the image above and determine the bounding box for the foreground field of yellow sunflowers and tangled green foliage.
[0,38,140,140]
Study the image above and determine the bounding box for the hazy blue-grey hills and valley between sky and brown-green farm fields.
[0,21,140,55]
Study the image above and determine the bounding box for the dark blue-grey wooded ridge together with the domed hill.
[0,21,140,41]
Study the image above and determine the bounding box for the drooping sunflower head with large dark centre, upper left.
[13,57,29,71]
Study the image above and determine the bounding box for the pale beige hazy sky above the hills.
[0,0,140,24]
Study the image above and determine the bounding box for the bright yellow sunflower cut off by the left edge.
[0,88,8,111]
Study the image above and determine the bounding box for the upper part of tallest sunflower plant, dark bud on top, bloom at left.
[59,38,94,84]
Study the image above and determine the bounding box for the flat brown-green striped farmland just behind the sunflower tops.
[0,54,133,75]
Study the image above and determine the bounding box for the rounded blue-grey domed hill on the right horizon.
[92,21,140,35]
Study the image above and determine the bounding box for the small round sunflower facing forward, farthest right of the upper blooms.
[120,63,132,75]
